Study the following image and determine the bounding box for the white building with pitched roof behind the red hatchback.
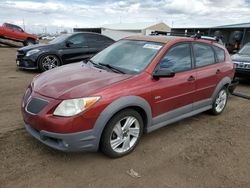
[101,22,171,40]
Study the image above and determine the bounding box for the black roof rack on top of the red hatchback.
[151,31,223,44]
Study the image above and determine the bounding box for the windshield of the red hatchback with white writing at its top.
[91,40,163,74]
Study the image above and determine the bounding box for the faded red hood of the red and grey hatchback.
[32,63,131,99]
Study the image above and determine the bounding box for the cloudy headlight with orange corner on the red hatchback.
[53,97,100,117]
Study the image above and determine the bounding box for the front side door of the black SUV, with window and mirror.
[59,33,90,64]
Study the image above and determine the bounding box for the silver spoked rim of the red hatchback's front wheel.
[110,116,140,153]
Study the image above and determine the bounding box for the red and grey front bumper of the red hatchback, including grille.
[21,87,101,152]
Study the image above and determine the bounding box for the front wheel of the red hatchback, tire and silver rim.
[100,109,143,158]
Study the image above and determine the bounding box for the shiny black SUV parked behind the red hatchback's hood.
[16,32,114,71]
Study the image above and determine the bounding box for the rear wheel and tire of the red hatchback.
[209,87,228,115]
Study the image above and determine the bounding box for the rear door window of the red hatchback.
[193,44,215,67]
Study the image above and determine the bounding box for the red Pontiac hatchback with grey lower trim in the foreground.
[21,36,235,158]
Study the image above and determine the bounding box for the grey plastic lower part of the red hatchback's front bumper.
[25,124,98,152]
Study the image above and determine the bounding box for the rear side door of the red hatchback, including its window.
[193,43,220,109]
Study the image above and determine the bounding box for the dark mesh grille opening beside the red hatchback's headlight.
[26,98,49,114]
